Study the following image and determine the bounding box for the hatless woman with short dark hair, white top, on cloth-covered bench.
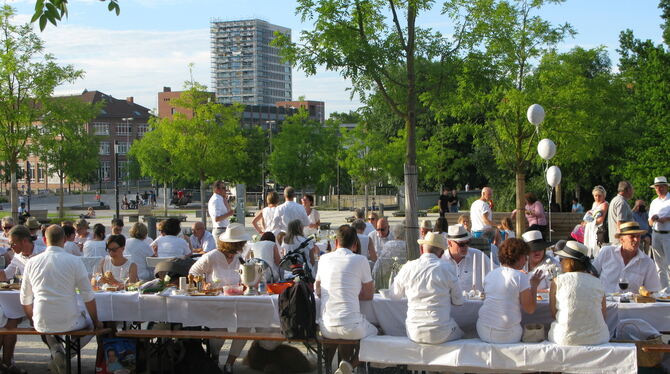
[477,238,542,343]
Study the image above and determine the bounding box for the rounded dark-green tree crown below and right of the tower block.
[269,109,338,191]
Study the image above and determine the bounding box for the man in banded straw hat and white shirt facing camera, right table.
[593,221,661,293]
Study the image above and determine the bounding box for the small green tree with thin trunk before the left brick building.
[35,98,100,218]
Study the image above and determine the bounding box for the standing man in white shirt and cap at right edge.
[649,177,670,288]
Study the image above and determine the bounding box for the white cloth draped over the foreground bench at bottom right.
[359,336,637,374]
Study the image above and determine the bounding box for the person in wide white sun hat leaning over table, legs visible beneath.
[189,223,251,373]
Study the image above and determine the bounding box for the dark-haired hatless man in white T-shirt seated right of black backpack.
[314,225,377,373]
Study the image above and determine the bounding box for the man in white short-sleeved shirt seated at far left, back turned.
[20,225,102,373]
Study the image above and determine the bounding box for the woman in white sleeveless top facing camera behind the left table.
[96,235,139,288]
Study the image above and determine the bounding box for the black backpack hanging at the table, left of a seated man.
[278,281,317,339]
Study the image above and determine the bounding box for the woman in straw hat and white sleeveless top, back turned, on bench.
[549,240,610,345]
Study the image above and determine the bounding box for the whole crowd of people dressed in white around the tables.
[0,177,670,373]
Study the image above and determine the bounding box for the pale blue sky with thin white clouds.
[7,0,661,117]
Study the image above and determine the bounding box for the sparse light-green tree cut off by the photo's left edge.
[0,5,83,221]
